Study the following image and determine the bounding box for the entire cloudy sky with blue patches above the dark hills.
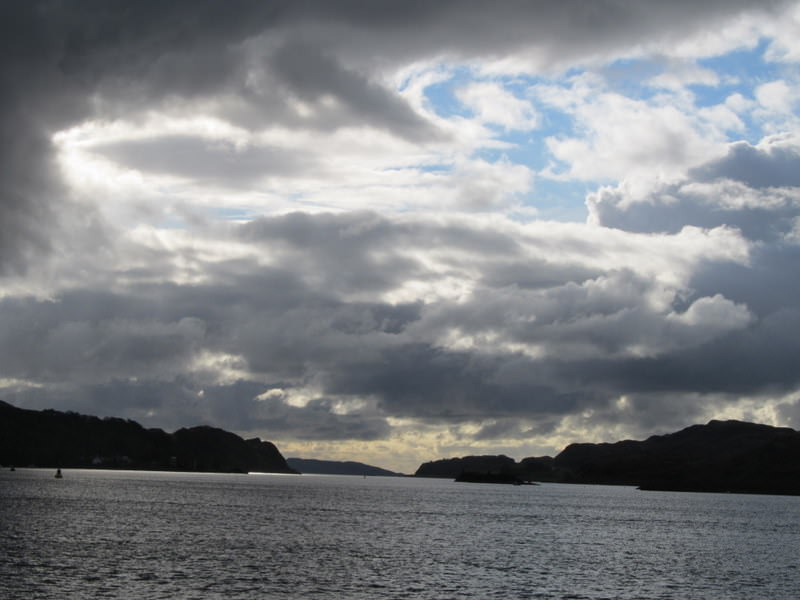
[0,0,800,472]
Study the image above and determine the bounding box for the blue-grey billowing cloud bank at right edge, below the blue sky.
[580,137,800,414]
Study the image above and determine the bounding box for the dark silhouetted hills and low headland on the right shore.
[415,421,800,495]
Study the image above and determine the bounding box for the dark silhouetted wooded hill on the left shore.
[0,401,296,473]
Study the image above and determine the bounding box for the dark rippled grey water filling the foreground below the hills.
[0,469,800,600]
